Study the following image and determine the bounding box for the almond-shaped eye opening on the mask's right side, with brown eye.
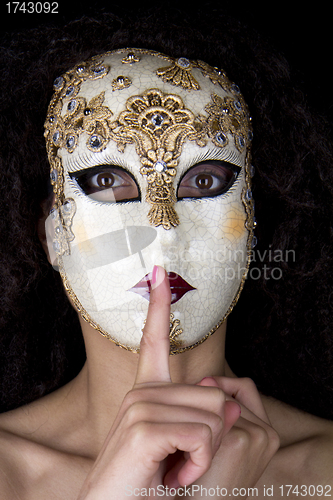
[177,160,241,200]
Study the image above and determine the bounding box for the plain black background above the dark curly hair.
[0,0,333,122]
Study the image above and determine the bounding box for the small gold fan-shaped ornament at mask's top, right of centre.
[156,57,200,90]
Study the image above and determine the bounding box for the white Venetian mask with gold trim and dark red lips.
[45,49,254,353]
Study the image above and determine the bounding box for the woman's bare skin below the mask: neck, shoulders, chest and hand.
[0,268,333,500]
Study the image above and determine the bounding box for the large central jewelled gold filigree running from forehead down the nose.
[110,89,206,229]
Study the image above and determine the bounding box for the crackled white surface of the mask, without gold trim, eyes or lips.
[50,48,248,349]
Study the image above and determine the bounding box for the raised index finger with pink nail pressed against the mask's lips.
[135,266,171,384]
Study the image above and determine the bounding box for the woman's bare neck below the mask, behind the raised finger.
[68,320,226,454]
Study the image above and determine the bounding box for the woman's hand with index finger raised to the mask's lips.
[78,267,276,500]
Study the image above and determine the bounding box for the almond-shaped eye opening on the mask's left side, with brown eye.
[68,164,141,203]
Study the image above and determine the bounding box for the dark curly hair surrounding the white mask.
[0,5,333,418]
